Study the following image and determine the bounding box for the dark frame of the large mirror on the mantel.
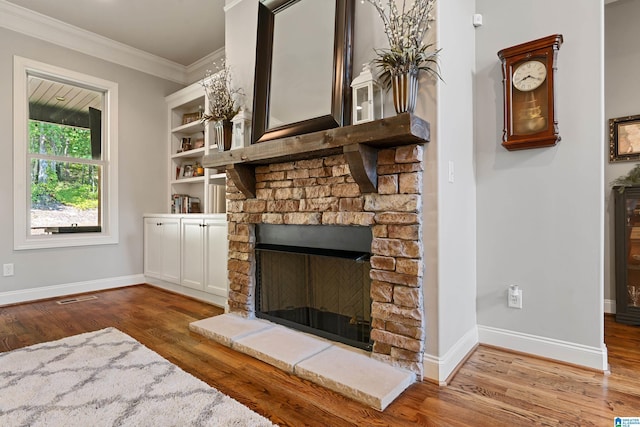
[251,0,354,144]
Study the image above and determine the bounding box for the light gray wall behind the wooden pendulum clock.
[476,0,604,348]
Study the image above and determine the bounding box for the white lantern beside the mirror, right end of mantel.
[351,64,384,125]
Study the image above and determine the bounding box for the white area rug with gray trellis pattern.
[0,328,273,427]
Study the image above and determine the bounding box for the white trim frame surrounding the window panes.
[13,56,118,250]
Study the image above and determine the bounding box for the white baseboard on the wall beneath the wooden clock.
[478,326,609,372]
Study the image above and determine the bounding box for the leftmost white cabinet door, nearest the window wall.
[144,217,180,283]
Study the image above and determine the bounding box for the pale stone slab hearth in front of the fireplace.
[189,313,416,410]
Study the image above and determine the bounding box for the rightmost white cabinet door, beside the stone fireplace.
[204,218,228,300]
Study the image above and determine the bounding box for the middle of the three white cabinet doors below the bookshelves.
[182,218,206,291]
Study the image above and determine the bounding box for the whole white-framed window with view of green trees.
[14,56,118,249]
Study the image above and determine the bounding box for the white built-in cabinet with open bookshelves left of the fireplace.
[144,82,228,307]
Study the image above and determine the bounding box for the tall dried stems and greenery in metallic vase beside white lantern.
[363,0,441,113]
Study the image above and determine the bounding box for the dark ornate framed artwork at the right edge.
[609,115,640,162]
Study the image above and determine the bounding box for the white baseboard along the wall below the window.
[0,274,145,305]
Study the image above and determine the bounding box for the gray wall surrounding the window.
[0,28,181,297]
